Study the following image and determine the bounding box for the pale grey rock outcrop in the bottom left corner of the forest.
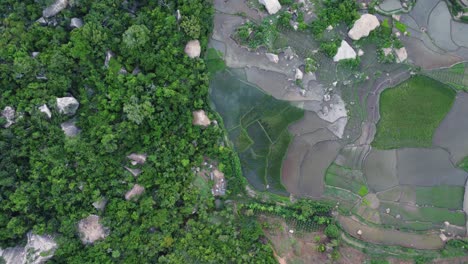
[0,232,57,264]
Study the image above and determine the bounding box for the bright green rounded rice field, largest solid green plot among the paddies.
[372,76,455,149]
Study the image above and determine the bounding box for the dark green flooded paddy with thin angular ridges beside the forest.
[211,71,303,194]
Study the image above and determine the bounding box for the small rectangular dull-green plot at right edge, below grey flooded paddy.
[416,185,465,209]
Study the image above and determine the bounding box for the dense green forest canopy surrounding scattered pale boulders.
[0,0,278,263]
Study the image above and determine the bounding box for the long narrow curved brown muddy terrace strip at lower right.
[338,215,444,249]
